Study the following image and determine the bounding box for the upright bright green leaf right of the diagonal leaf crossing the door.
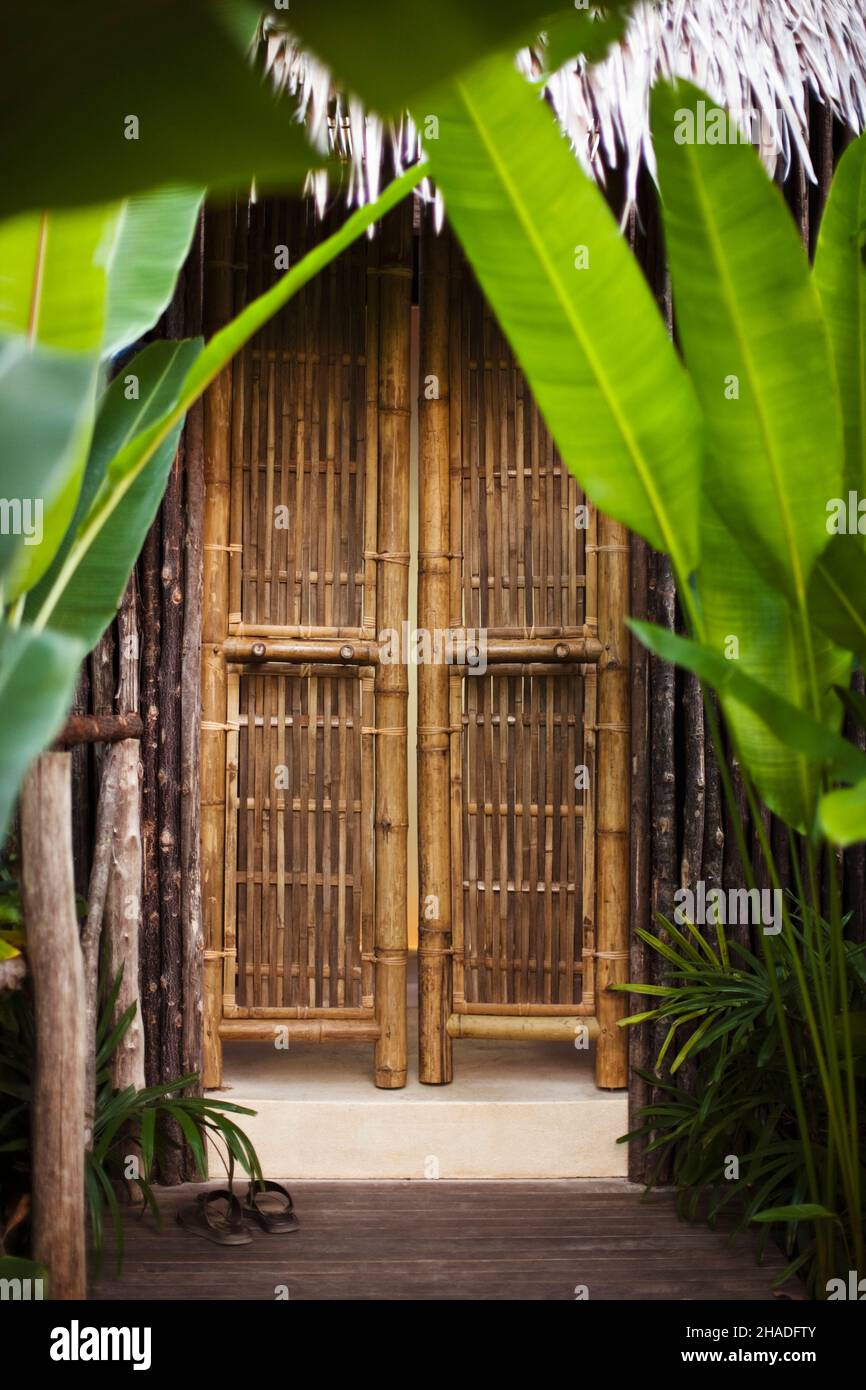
[653,83,842,610]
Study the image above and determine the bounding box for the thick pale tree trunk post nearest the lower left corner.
[21,753,86,1298]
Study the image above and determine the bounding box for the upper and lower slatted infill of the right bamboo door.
[452,265,596,1015]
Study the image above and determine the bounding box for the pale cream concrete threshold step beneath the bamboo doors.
[209,1041,628,1182]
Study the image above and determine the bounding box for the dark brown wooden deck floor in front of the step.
[93,1182,783,1301]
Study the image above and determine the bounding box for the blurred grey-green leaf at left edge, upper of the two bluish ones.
[0,346,96,600]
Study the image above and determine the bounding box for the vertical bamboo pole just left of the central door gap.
[375,206,411,1090]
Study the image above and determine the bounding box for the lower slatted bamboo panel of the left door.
[228,670,373,1013]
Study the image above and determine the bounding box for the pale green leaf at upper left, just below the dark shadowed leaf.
[101,188,203,356]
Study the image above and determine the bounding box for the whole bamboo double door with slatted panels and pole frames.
[202,202,627,1088]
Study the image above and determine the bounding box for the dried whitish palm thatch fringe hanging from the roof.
[265,0,866,215]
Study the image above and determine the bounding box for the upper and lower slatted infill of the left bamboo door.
[224,200,377,1020]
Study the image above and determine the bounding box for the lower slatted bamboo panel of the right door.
[461,676,584,1005]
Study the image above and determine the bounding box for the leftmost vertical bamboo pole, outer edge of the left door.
[202,198,234,1087]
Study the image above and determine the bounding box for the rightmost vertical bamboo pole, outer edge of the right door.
[595,517,631,1088]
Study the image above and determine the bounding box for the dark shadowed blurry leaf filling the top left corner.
[0,0,330,215]
